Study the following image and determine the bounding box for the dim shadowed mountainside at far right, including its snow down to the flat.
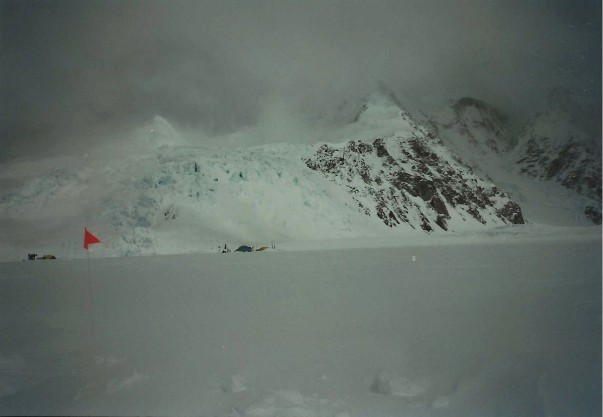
[422,98,601,225]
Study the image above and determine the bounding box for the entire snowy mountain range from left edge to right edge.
[0,90,601,259]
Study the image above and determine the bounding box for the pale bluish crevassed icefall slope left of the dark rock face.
[0,135,387,257]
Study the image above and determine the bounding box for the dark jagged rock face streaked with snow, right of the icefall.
[305,130,524,232]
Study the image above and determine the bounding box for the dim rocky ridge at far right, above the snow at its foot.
[423,91,601,224]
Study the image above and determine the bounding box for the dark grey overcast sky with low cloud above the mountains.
[0,0,601,158]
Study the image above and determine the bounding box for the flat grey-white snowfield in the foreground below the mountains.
[0,226,601,417]
